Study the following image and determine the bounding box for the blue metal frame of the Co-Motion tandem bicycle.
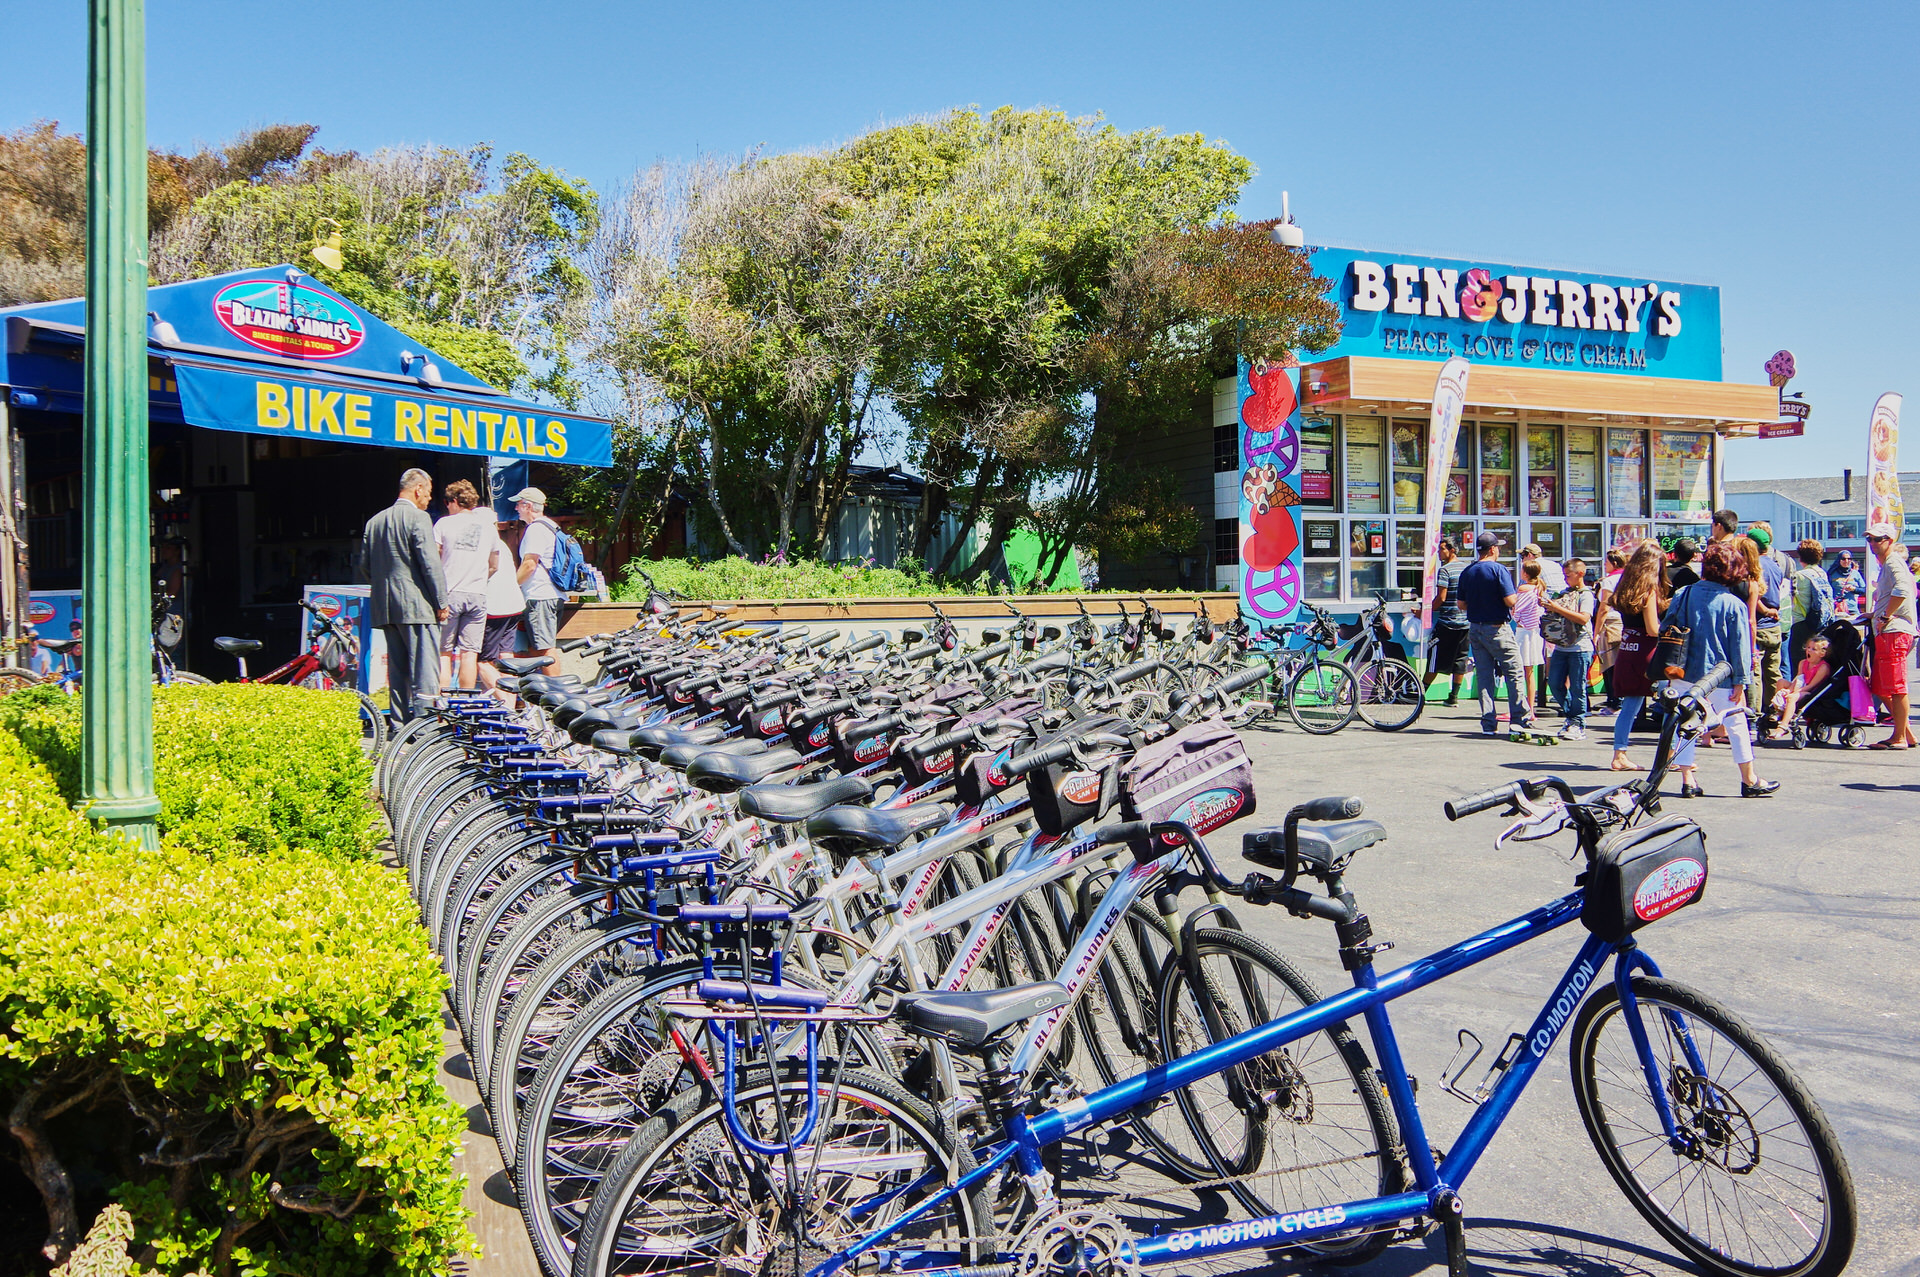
[808,891,1705,1277]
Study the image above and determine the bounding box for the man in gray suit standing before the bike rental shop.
[361,469,447,722]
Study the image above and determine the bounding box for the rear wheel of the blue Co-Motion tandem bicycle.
[572,1062,993,1277]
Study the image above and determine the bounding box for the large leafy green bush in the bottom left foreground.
[0,841,465,1275]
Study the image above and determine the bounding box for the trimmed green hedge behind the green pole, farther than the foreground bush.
[0,684,376,858]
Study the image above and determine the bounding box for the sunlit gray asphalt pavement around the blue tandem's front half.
[1212,703,1920,1277]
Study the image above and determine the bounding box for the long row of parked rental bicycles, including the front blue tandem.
[378,599,1853,1277]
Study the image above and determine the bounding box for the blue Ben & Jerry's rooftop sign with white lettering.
[1313,248,1720,382]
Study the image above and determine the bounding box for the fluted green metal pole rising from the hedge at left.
[81,0,159,847]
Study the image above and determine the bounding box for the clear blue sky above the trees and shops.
[0,0,1920,478]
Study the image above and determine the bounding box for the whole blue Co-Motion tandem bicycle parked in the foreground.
[572,666,1857,1277]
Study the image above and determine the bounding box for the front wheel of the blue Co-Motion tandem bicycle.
[1569,976,1859,1277]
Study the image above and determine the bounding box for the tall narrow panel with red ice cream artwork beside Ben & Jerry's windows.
[1238,359,1302,628]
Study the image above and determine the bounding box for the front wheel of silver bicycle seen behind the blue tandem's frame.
[1160,928,1405,1262]
